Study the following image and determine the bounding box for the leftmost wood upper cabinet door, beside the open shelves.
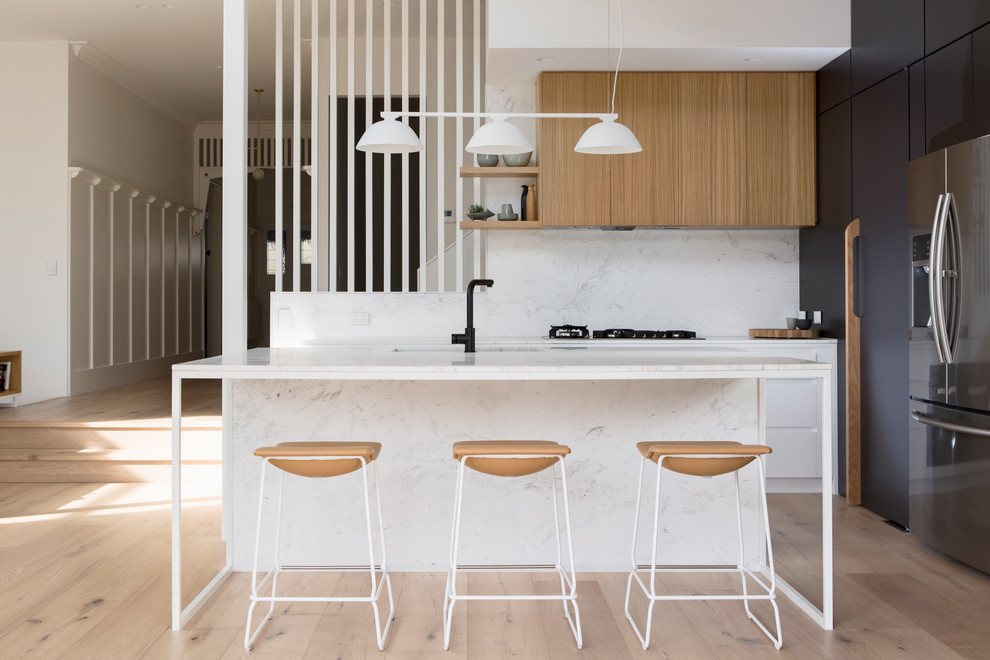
[537,72,611,227]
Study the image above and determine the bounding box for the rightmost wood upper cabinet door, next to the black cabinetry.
[744,73,815,227]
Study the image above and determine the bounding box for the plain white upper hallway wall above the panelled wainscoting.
[68,57,193,207]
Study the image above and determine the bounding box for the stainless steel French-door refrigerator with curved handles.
[912,136,990,573]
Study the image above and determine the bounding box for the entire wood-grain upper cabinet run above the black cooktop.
[537,72,815,227]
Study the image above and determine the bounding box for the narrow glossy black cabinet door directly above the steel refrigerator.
[925,36,976,153]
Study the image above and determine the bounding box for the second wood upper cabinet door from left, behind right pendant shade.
[611,72,684,226]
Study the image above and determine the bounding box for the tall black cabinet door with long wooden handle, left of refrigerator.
[852,71,911,526]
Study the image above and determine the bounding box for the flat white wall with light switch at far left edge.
[0,42,69,403]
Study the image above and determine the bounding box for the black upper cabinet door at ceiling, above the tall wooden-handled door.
[851,0,925,94]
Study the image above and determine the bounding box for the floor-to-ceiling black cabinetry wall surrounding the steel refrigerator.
[800,0,990,526]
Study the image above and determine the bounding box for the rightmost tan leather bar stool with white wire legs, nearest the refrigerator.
[626,442,782,651]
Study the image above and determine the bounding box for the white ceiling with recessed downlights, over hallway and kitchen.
[0,0,849,127]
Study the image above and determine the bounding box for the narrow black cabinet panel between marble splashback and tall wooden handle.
[799,99,852,494]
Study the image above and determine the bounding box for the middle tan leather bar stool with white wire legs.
[443,440,582,651]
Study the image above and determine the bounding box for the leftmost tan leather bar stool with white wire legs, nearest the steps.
[244,442,395,651]
